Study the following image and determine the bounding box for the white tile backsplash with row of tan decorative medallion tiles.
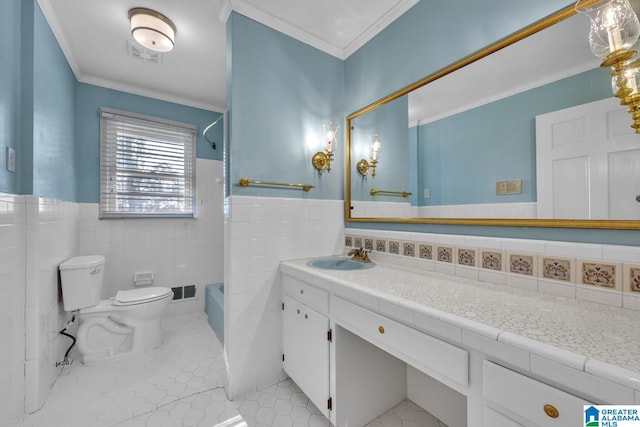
[345,229,640,310]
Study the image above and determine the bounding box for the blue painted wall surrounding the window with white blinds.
[76,83,223,203]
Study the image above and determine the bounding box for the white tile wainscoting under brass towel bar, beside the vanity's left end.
[224,196,344,398]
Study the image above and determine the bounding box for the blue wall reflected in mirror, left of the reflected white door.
[418,68,612,206]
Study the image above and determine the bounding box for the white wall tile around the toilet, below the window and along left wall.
[0,159,224,426]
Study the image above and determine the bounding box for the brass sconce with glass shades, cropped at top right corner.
[576,0,640,133]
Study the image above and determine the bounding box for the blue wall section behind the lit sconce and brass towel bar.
[227,12,345,199]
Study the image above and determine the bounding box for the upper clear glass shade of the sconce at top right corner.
[576,0,640,58]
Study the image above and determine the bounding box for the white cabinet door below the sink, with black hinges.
[282,295,329,418]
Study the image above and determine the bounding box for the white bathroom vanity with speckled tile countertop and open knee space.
[280,260,640,427]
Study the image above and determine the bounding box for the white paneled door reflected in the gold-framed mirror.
[536,98,640,219]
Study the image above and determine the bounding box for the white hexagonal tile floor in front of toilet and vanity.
[22,313,446,427]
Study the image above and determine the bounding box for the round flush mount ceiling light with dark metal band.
[129,7,176,52]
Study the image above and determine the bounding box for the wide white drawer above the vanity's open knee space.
[331,297,469,386]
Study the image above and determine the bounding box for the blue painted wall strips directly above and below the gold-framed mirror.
[345,0,640,245]
